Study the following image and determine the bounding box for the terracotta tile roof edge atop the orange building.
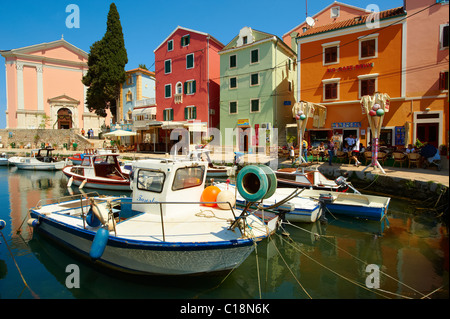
[298,7,406,38]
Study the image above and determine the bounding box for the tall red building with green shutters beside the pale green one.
[154,27,223,151]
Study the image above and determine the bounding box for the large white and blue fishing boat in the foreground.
[28,159,279,275]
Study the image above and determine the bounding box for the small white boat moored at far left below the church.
[8,148,68,171]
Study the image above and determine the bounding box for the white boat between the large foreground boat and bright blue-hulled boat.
[214,183,322,223]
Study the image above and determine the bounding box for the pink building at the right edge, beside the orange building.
[404,0,449,148]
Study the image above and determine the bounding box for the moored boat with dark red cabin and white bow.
[63,153,131,191]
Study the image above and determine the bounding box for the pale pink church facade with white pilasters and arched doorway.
[0,39,109,133]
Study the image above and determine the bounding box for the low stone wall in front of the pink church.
[0,129,93,150]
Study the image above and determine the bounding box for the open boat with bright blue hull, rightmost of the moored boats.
[301,189,391,220]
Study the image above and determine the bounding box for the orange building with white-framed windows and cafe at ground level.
[296,7,409,145]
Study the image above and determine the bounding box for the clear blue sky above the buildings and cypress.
[0,0,403,128]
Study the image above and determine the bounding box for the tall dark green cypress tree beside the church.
[82,3,128,117]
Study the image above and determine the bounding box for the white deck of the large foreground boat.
[33,198,273,243]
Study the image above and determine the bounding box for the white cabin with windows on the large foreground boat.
[132,159,208,217]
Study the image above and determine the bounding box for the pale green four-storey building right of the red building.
[219,27,296,152]
